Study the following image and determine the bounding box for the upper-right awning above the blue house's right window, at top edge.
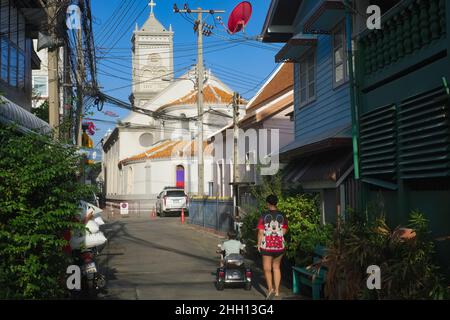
[304,0,345,34]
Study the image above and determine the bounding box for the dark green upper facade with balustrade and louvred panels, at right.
[357,0,450,180]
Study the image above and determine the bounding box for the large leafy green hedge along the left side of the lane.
[0,126,91,299]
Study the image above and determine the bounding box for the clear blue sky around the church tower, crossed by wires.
[89,0,280,145]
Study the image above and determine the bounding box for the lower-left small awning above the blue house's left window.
[275,34,317,63]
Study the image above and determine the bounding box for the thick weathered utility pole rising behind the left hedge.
[47,0,59,139]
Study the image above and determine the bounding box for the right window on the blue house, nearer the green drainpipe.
[332,23,349,87]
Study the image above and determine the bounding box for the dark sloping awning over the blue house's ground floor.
[282,149,353,185]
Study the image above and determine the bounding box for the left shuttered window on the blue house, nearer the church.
[299,51,316,105]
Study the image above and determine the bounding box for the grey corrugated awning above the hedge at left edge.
[0,97,52,134]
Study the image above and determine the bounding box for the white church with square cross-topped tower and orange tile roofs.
[103,1,245,212]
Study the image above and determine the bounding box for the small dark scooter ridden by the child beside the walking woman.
[216,244,253,291]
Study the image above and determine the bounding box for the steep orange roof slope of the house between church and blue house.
[247,63,294,110]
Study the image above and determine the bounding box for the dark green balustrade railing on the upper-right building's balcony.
[359,0,447,75]
